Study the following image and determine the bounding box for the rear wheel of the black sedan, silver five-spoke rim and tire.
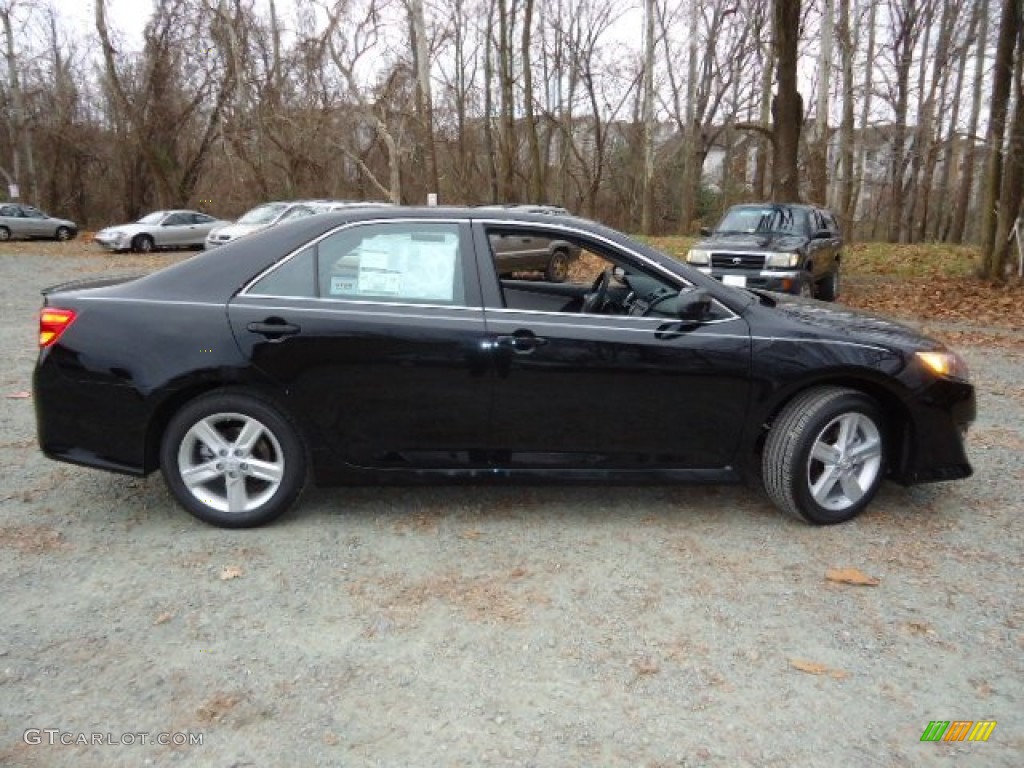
[160,391,306,528]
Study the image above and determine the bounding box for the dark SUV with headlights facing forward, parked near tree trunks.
[686,203,843,301]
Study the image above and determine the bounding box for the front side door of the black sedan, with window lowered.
[475,221,751,470]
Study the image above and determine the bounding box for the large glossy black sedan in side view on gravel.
[34,208,975,527]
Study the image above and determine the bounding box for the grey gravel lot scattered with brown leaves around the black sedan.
[0,246,1024,768]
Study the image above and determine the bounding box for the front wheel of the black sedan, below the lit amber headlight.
[761,387,886,525]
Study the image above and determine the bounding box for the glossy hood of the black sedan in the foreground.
[765,292,943,350]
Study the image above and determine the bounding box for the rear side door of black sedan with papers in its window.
[228,219,492,470]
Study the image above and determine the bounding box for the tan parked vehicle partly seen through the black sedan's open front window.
[476,203,580,283]
